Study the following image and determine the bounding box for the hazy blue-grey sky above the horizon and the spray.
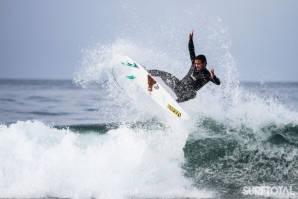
[0,0,298,81]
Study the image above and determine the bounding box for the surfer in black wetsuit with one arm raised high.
[148,30,220,103]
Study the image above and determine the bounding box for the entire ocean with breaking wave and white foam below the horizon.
[0,79,298,198]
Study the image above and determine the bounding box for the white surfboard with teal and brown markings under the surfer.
[121,56,191,120]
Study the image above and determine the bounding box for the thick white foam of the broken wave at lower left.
[0,121,211,198]
